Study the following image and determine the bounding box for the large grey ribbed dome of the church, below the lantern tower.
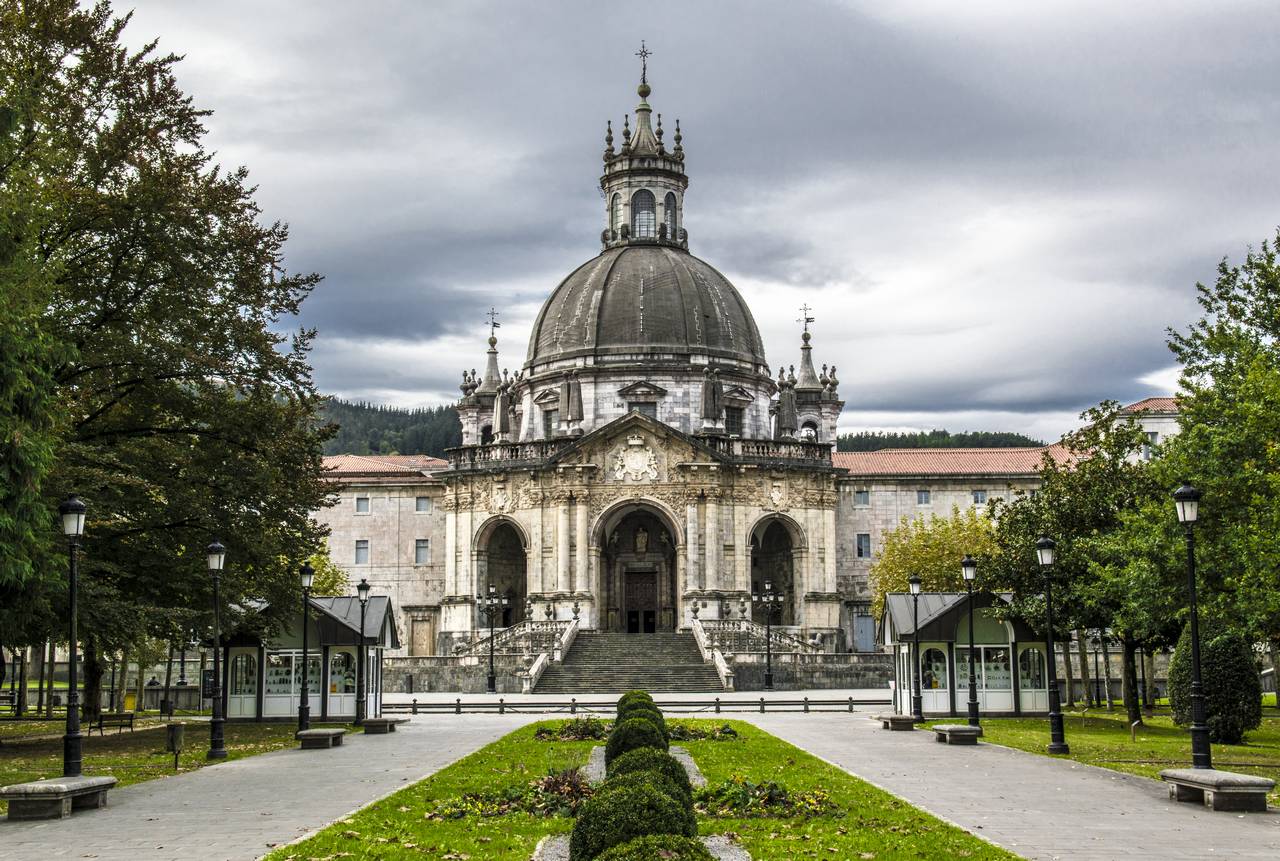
[526,244,765,372]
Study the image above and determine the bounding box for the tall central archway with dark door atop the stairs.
[600,504,680,633]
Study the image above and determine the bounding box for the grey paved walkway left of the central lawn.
[0,715,536,861]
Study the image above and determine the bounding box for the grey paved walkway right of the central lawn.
[735,714,1280,861]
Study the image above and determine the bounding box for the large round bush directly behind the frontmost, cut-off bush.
[568,777,698,861]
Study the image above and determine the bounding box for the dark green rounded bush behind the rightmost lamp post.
[1169,626,1262,745]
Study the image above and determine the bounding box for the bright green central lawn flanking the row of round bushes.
[268,720,1018,861]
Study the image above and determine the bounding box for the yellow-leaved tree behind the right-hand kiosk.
[870,508,998,617]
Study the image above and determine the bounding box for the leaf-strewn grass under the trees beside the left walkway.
[0,722,357,811]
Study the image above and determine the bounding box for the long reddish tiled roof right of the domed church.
[832,444,1074,477]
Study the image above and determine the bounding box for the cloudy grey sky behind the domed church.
[120,0,1280,439]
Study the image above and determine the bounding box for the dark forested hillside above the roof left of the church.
[324,398,462,457]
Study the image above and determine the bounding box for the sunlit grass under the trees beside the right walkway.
[933,710,1280,803]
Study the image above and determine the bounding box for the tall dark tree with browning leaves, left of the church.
[0,0,332,709]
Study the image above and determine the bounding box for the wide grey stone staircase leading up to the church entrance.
[534,631,724,696]
